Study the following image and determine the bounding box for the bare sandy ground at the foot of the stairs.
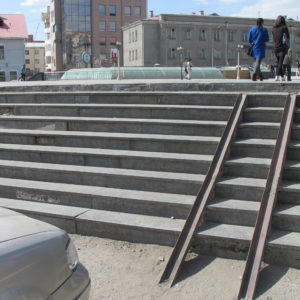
[71,235,300,300]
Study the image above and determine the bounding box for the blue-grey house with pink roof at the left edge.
[0,14,28,81]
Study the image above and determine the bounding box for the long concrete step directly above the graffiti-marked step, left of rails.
[0,160,204,195]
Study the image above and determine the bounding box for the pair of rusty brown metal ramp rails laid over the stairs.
[159,94,296,300]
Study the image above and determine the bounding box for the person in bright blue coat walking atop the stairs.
[248,18,269,81]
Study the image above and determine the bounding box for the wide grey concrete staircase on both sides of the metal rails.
[0,92,300,267]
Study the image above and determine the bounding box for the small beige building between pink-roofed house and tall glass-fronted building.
[25,35,45,75]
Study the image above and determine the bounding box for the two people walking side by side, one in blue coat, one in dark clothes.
[248,16,291,81]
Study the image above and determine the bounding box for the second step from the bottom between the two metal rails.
[206,198,260,226]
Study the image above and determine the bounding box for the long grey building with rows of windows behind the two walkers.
[123,14,300,67]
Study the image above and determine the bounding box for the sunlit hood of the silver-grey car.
[0,207,59,243]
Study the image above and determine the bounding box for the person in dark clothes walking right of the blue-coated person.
[272,16,290,81]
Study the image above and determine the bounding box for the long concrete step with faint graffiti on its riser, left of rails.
[0,178,195,219]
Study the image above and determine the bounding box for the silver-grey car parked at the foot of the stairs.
[0,207,90,300]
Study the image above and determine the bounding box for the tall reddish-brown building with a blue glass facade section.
[43,0,147,70]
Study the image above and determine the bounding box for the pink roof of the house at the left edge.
[0,14,28,39]
